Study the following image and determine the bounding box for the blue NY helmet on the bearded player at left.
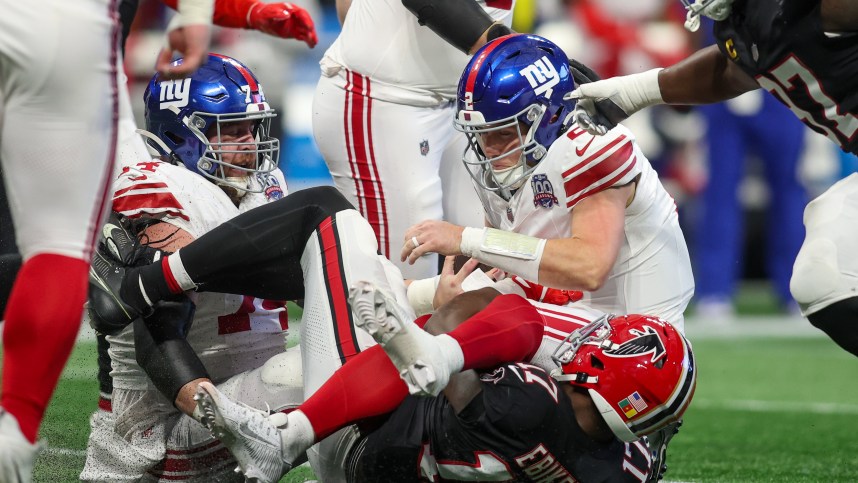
[141,54,280,192]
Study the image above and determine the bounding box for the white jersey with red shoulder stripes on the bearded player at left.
[108,160,287,389]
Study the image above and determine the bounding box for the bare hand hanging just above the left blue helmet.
[155,24,211,79]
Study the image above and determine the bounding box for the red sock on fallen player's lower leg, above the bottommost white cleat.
[298,346,408,441]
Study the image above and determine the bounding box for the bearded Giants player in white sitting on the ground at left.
[81,54,300,481]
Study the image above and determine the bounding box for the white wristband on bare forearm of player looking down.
[459,227,546,283]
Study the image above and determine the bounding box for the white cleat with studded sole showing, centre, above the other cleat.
[349,282,450,396]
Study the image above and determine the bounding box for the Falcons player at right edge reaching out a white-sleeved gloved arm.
[569,0,858,355]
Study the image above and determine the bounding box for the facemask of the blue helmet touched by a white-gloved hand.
[454,104,548,200]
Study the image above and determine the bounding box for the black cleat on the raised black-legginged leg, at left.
[87,213,160,335]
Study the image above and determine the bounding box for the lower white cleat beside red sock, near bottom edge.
[194,382,292,483]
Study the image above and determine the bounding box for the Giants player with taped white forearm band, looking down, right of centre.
[401,35,694,475]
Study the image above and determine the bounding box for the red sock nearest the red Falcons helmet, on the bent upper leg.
[447,295,545,370]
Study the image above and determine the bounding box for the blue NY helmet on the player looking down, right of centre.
[455,35,575,199]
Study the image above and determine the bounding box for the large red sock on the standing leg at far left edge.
[0,254,89,442]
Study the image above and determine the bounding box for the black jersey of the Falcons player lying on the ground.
[349,363,650,483]
